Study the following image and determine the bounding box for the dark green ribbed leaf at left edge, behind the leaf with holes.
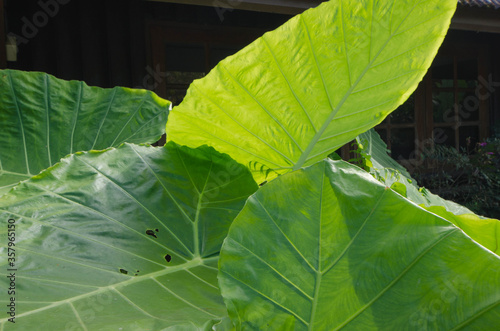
[0,70,170,195]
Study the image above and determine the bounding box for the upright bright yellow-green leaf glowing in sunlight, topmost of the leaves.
[167,0,457,181]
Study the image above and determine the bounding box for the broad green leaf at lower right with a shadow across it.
[219,161,500,330]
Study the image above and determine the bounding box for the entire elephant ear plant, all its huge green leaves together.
[0,0,500,330]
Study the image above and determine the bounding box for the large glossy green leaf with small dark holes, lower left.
[0,143,258,331]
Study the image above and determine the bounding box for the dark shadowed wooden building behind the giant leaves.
[0,0,500,161]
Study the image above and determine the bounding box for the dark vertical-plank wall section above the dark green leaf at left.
[6,0,146,87]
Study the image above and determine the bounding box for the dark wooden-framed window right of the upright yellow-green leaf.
[376,43,489,166]
